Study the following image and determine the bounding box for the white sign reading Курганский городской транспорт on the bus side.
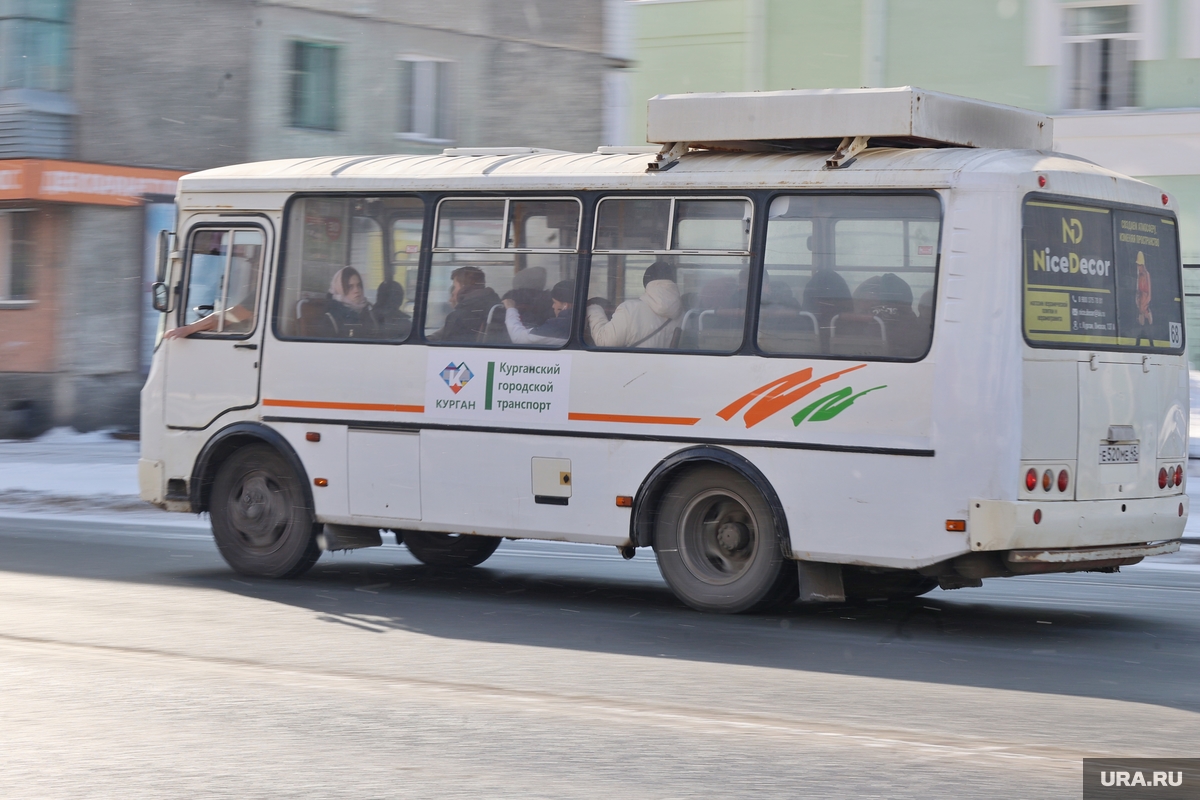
[425,348,571,423]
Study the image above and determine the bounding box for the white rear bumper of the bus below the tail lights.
[967,494,1188,551]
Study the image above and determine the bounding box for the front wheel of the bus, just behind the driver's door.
[209,444,320,578]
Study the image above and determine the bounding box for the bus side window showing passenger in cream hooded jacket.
[586,197,752,353]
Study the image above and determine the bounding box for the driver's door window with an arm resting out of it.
[184,228,264,336]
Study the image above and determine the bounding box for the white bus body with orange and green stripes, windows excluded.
[139,89,1188,610]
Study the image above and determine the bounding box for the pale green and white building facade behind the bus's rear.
[628,0,1200,368]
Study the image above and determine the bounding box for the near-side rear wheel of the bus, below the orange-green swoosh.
[654,464,798,614]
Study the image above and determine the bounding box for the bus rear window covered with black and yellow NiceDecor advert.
[1024,198,1183,353]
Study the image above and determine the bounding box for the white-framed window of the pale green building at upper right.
[1063,5,1139,110]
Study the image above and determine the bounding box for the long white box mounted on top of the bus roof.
[646,86,1054,150]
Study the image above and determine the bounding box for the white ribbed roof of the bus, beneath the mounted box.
[179,148,1174,206]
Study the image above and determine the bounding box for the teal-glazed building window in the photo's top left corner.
[0,0,71,91]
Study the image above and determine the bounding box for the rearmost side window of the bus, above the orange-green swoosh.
[757,196,941,359]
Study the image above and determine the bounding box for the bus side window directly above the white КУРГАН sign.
[425,198,581,347]
